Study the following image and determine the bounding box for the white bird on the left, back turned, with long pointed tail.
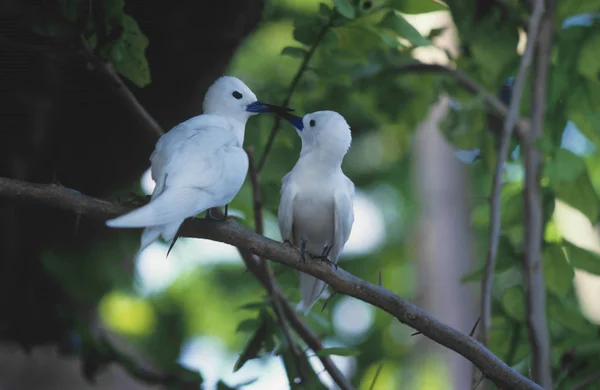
[106,76,292,252]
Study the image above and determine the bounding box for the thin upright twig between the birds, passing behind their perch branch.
[246,147,307,383]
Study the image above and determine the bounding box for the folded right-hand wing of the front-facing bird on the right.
[330,176,354,261]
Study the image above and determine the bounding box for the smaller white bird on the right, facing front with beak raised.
[278,111,354,314]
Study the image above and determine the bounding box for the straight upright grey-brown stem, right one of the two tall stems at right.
[523,0,554,389]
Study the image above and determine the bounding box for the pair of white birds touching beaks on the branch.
[106,76,354,314]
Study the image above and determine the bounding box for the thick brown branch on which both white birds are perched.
[0,178,541,390]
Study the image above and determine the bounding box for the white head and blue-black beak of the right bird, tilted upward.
[280,111,352,157]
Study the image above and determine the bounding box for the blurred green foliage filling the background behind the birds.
[17,0,600,389]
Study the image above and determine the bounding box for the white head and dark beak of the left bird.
[204,76,293,122]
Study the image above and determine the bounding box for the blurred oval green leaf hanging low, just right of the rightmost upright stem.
[543,244,575,295]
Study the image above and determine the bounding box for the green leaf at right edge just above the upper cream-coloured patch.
[556,171,598,223]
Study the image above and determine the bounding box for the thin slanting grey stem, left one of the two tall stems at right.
[480,0,544,345]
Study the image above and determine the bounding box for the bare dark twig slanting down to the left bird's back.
[80,36,164,139]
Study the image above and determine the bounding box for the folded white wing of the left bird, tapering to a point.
[106,116,240,227]
